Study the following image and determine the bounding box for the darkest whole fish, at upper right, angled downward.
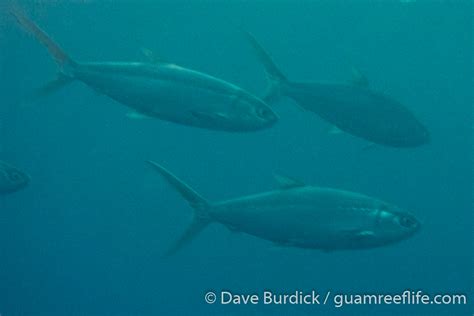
[245,32,430,147]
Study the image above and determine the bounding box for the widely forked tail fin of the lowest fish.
[148,161,212,255]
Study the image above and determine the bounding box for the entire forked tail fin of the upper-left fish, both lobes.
[9,4,77,97]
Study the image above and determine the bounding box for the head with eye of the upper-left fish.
[229,95,278,131]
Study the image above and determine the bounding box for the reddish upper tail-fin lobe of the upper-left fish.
[10,5,76,71]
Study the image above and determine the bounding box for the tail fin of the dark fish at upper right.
[243,31,288,102]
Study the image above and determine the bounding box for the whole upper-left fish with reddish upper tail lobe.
[11,7,277,132]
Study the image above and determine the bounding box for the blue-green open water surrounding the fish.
[0,0,474,316]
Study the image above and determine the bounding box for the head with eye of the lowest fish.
[375,203,421,243]
